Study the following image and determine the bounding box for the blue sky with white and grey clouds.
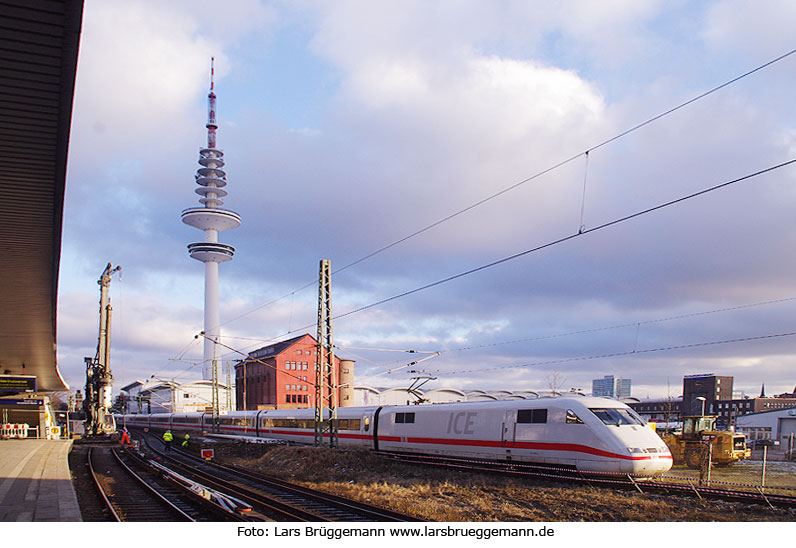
[58,0,796,397]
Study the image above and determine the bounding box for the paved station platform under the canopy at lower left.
[0,439,82,522]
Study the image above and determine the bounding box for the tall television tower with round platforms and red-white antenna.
[182,59,240,380]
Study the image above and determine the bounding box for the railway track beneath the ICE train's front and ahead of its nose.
[377,452,796,508]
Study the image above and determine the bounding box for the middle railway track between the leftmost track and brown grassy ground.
[138,432,418,522]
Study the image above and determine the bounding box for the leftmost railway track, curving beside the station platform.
[86,447,255,522]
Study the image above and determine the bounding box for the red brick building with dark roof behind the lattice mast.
[235,335,354,411]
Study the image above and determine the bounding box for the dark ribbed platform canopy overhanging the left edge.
[0,0,83,391]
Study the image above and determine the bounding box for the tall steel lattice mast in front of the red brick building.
[315,259,338,447]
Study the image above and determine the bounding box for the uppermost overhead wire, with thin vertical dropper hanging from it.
[211,49,796,334]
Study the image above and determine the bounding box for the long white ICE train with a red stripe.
[117,397,672,476]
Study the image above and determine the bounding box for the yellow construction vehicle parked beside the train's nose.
[663,415,752,468]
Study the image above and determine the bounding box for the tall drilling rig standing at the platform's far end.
[83,263,122,436]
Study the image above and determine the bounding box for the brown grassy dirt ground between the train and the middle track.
[214,444,796,522]
